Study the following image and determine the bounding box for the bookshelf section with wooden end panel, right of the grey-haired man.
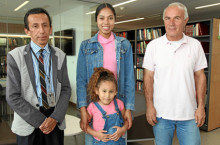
[185,18,220,131]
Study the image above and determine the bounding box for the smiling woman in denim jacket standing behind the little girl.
[76,3,135,145]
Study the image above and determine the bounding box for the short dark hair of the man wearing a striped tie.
[24,8,51,30]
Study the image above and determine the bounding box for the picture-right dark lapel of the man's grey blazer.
[49,46,58,94]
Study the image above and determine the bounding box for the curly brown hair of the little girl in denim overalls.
[87,67,118,101]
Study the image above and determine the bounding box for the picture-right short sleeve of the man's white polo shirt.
[194,42,208,72]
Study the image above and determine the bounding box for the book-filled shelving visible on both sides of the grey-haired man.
[117,18,220,131]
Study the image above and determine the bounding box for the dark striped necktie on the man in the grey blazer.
[39,49,49,109]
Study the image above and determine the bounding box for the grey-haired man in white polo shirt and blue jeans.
[143,2,207,145]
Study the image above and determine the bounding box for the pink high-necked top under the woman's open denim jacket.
[98,33,117,79]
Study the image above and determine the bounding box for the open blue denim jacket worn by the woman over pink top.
[76,33,135,110]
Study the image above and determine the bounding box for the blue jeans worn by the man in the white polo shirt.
[153,118,201,145]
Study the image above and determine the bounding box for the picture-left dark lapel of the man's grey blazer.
[24,44,37,96]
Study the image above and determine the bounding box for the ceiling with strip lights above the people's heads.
[0,0,220,29]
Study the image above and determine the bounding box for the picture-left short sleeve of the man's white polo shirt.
[142,42,155,71]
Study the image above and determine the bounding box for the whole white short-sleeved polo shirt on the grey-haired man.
[143,34,207,120]
